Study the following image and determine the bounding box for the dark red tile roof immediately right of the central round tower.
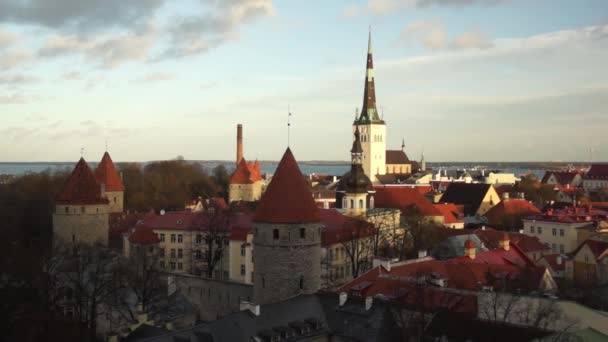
[319,209,374,247]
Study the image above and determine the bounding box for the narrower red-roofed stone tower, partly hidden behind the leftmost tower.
[95,152,125,213]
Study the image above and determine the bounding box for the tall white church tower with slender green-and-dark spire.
[353,29,386,183]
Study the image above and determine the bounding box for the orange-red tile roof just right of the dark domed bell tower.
[374,186,442,216]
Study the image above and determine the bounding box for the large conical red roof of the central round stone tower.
[254,148,320,223]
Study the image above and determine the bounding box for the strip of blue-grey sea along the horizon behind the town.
[0,161,548,178]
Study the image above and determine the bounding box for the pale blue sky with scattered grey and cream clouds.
[0,0,608,161]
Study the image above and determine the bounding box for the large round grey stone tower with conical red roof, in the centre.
[253,148,321,304]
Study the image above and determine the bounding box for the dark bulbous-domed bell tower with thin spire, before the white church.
[336,129,376,216]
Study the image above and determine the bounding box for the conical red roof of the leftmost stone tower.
[56,158,108,204]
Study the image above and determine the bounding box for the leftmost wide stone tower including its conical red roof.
[53,158,109,246]
